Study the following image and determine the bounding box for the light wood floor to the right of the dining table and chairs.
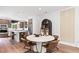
[58,44,79,53]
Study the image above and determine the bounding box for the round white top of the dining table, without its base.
[27,35,54,42]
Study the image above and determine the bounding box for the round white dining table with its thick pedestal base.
[27,35,54,53]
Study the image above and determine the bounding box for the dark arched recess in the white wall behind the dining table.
[41,19,52,35]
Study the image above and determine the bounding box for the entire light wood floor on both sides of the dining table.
[0,38,79,53]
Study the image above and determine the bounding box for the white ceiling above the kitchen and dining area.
[0,6,68,20]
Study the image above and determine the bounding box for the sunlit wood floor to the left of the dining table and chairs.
[0,38,26,53]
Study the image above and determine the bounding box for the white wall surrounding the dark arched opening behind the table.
[33,11,60,36]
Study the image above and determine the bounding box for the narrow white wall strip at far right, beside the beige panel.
[75,7,79,46]
